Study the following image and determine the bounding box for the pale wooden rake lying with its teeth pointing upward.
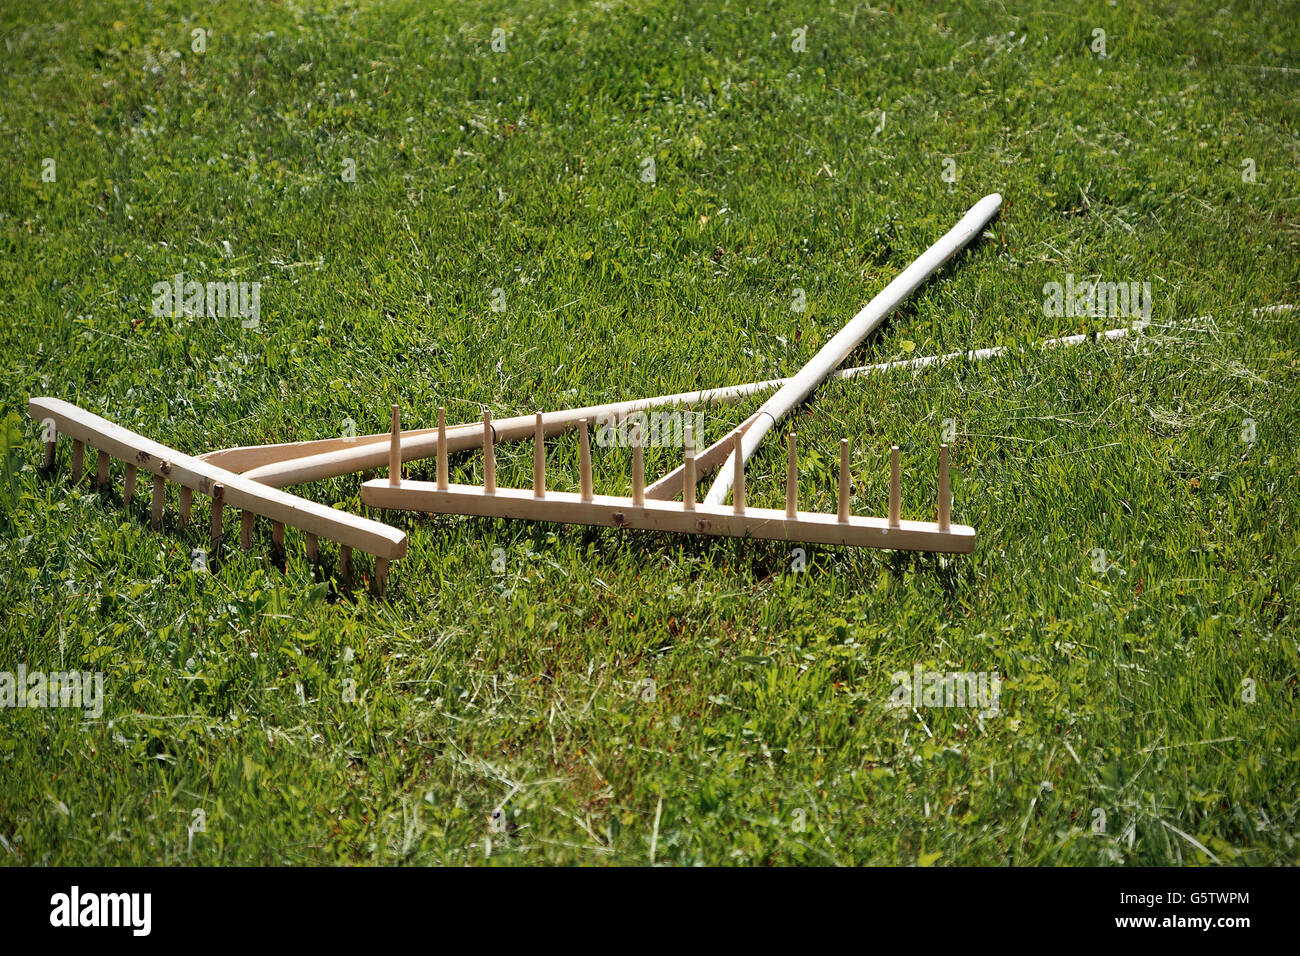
[358,194,1002,554]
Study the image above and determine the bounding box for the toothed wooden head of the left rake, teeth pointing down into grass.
[27,398,407,593]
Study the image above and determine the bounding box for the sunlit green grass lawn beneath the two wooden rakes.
[0,0,1300,865]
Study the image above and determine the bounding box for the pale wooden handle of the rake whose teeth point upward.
[705,193,1002,506]
